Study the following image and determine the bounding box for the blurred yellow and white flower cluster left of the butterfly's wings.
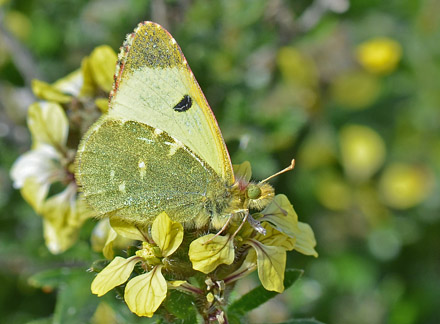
[11,46,117,253]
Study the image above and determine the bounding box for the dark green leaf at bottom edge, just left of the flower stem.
[164,290,197,323]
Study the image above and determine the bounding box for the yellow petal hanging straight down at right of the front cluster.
[247,239,286,293]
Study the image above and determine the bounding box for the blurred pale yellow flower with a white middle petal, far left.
[11,102,91,254]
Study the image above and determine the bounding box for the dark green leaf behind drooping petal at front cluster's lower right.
[228,269,303,323]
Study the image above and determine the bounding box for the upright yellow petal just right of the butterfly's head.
[258,195,298,237]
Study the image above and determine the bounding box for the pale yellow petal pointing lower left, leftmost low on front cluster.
[91,256,141,297]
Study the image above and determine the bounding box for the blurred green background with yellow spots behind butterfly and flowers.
[0,0,440,324]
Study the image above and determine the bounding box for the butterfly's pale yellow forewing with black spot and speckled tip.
[109,22,234,185]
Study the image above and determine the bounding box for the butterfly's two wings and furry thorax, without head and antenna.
[76,22,273,227]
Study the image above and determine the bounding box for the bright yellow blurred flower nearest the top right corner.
[356,37,402,74]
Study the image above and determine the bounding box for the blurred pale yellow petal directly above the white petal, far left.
[27,102,69,151]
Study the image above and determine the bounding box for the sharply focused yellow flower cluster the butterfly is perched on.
[92,162,317,318]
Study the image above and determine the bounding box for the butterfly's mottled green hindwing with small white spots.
[78,118,226,223]
